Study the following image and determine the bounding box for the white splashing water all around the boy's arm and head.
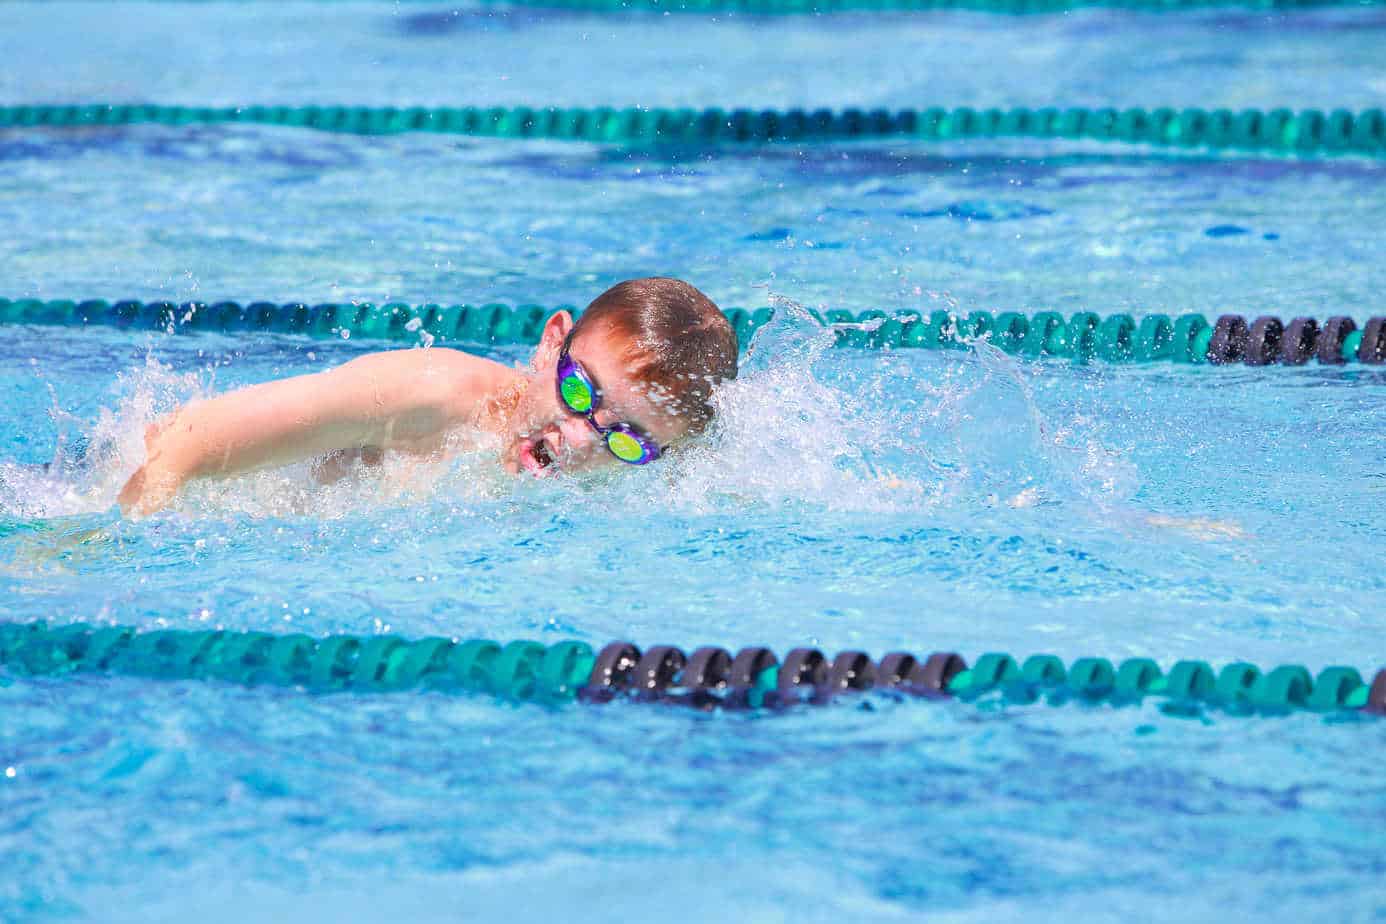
[0,294,1138,518]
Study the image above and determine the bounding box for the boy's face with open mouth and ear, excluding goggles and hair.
[500,312,687,477]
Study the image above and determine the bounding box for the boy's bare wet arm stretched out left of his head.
[119,349,470,515]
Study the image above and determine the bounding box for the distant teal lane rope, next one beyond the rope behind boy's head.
[0,104,1386,157]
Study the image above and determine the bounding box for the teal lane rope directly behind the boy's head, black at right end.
[0,298,1386,366]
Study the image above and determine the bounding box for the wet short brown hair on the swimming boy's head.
[572,276,737,432]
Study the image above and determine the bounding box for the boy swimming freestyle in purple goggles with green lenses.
[119,277,737,515]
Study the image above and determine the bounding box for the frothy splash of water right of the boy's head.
[612,295,1139,523]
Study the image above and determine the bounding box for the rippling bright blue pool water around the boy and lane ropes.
[0,3,1386,921]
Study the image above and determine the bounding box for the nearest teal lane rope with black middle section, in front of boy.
[0,622,1386,715]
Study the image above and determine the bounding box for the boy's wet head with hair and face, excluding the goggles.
[503,277,737,474]
